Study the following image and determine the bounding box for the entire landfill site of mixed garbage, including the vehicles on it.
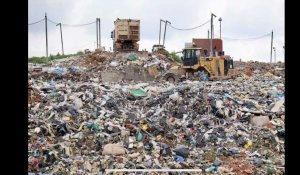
[28,19,285,175]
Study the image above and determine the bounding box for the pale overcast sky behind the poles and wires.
[28,0,284,62]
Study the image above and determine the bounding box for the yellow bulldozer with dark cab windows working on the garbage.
[162,46,236,82]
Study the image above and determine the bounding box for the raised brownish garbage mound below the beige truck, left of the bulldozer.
[29,51,177,82]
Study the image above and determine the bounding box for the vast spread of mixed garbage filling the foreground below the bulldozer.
[28,54,285,175]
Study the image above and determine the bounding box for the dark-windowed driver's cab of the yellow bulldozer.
[181,48,201,66]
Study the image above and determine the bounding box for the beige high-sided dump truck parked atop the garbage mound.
[111,18,140,51]
